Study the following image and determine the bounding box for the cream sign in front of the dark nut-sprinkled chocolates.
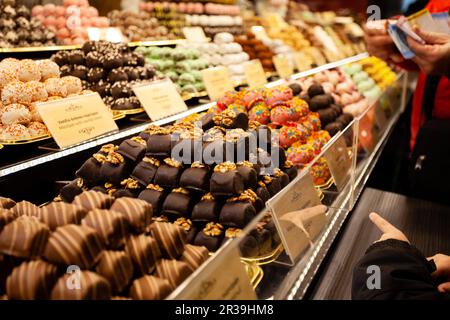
[133,79,187,121]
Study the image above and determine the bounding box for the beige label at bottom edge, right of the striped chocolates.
[168,244,256,300]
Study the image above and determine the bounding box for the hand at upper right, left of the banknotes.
[364,20,404,63]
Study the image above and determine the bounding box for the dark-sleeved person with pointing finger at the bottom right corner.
[352,213,450,301]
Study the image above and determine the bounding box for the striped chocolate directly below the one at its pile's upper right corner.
[125,234,161,275]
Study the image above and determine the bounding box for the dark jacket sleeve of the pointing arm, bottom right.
[352,239,450,300]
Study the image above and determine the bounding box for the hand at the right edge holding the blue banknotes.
[407,28,450,75]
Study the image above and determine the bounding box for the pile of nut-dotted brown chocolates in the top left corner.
[0,0,57,48]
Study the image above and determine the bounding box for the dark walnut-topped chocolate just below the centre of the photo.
[210,162,244,197]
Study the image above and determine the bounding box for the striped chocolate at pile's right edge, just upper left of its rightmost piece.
[150,222,187,259]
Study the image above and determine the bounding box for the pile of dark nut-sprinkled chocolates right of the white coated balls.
[52,41,156,110]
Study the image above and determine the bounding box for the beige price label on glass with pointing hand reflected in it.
[268,174,324,263]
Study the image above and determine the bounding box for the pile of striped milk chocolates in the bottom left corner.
[0,191,208,300]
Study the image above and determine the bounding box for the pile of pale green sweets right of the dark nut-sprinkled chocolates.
[135,44,209,95]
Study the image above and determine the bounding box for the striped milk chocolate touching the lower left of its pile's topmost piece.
[40,202,87,231]
